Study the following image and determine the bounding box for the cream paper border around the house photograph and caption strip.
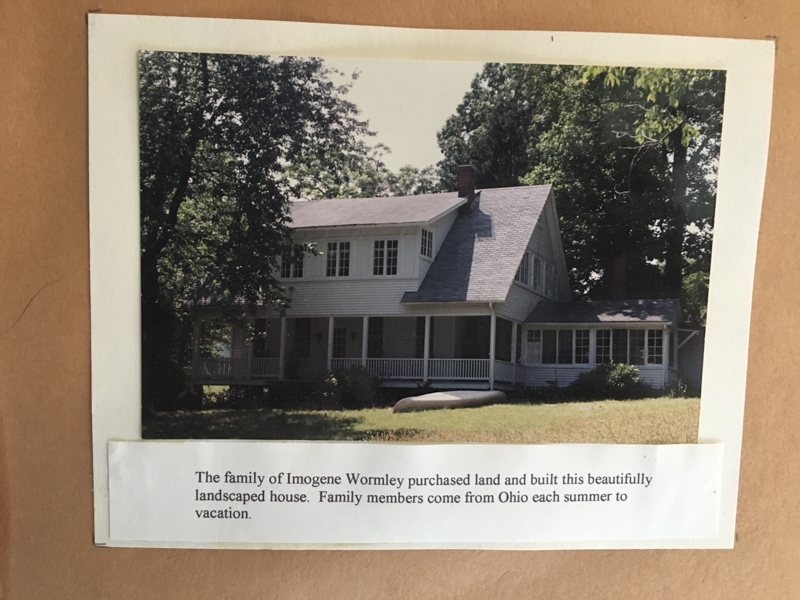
[88,14,775,548]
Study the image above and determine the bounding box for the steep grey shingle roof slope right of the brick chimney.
[402,185,551,302]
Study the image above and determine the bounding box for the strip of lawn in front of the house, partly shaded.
[142,398,700,444]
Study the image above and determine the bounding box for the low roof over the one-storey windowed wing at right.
[525,300,680,323]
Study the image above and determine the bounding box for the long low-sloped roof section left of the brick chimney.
[291,192,466,229]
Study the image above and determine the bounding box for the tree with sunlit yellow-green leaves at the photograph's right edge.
[584,67,725,290]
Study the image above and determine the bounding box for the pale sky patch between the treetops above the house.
[325,58,483,171]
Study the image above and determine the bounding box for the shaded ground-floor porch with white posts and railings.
[193,315,524,389]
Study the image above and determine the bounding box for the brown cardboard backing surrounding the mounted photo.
[0,0,800,599]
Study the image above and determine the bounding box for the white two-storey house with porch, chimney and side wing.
[193,167,679,389]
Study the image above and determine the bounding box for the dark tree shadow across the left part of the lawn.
[142,409,416,441]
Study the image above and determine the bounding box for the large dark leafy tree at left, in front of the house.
[139,52,369,406]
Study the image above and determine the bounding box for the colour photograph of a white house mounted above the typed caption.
[138,50,726,444]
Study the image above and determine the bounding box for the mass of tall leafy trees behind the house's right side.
[439,64,724,314]
